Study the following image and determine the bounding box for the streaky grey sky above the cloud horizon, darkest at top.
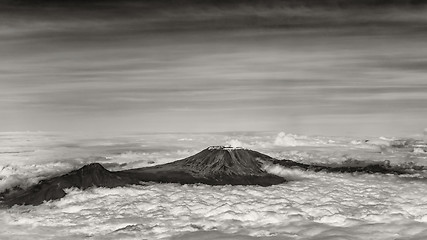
[0,0,427,135]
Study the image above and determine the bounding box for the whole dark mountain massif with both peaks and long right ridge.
[0,146,414,207]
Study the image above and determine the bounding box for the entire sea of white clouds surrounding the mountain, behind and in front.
[0,133,427,239]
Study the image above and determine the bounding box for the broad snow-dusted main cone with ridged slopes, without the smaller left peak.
[124,146,285,186]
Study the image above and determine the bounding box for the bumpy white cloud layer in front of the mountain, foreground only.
[0,173,427,240]
